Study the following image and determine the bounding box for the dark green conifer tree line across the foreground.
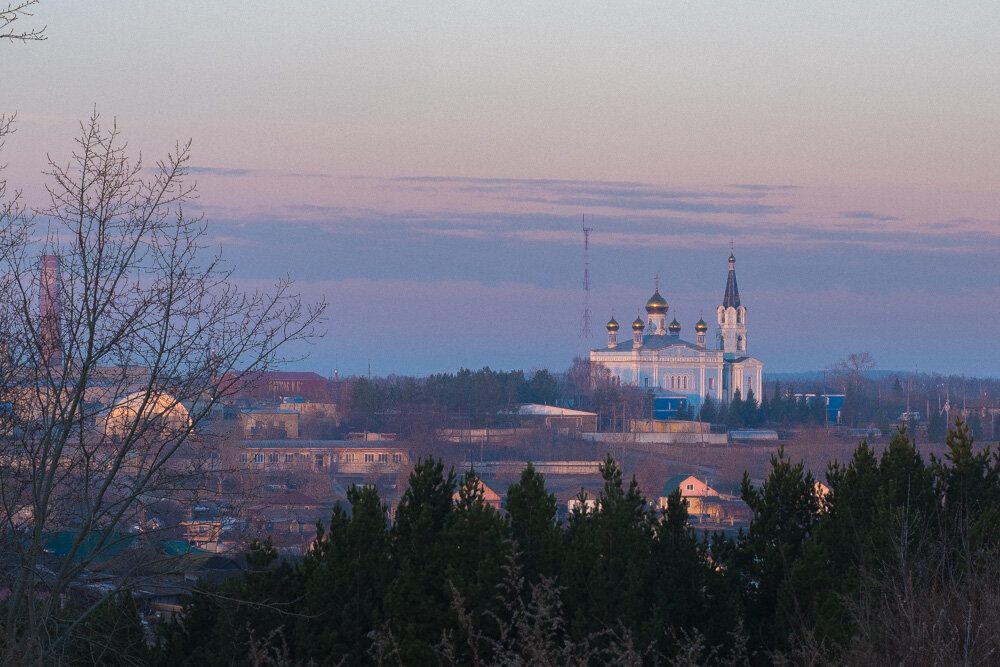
[150,421,1000,665]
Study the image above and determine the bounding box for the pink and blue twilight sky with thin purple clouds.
[0,0,1000,376]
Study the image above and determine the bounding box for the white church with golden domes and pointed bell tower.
[590,254,764,411]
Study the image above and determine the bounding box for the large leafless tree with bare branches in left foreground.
[0,112,324,664]
